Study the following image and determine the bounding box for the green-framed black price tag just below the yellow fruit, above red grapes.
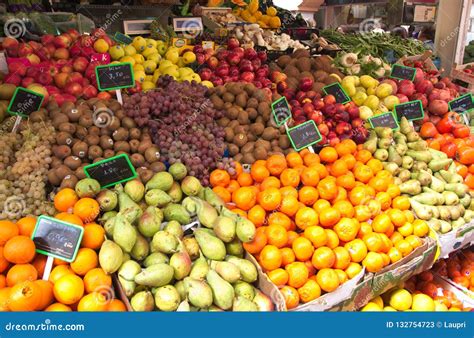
[95,62,135,91]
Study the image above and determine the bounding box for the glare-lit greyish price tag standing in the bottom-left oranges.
[31,216,84,263]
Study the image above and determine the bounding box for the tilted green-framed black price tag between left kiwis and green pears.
[84,154,137,188]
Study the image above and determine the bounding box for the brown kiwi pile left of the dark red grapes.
[30,98,166,188]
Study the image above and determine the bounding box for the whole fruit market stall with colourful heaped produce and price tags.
[0,0,474,311]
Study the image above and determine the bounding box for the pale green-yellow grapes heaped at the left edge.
[0,123,55,219]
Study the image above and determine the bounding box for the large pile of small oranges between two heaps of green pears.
[210,140,429,309]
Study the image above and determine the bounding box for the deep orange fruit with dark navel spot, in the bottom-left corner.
[8,281,42,311]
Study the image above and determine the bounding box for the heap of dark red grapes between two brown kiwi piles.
[123,76,226,185]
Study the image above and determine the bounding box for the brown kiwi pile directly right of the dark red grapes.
[209,82,292,164]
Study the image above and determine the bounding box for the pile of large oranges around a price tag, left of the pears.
[0,189,126,311]
